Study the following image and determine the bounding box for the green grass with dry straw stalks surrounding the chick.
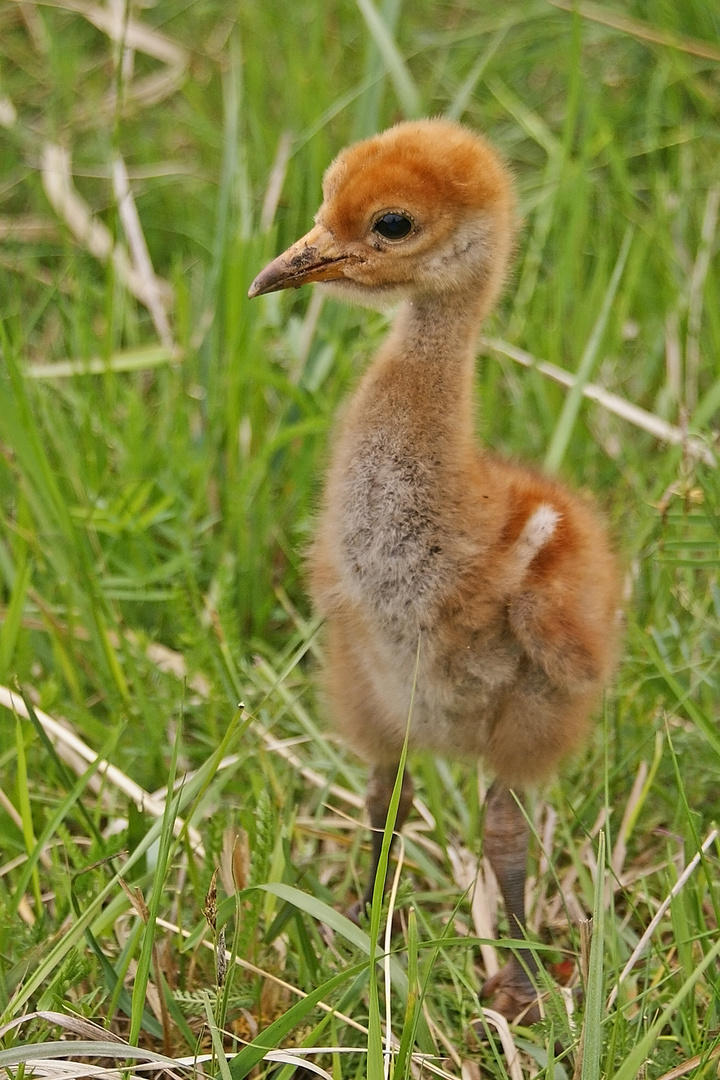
[0,0,720,1080]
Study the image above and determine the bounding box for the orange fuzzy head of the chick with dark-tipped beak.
[248,120,513,308]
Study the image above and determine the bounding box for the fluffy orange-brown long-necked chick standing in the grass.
[248,118,621,1023]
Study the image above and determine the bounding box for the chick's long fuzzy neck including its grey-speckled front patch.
[314,285,496,626]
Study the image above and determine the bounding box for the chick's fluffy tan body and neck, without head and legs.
[311,300,616,784]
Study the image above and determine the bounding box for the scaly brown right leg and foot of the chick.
[481,781,540,1024]
